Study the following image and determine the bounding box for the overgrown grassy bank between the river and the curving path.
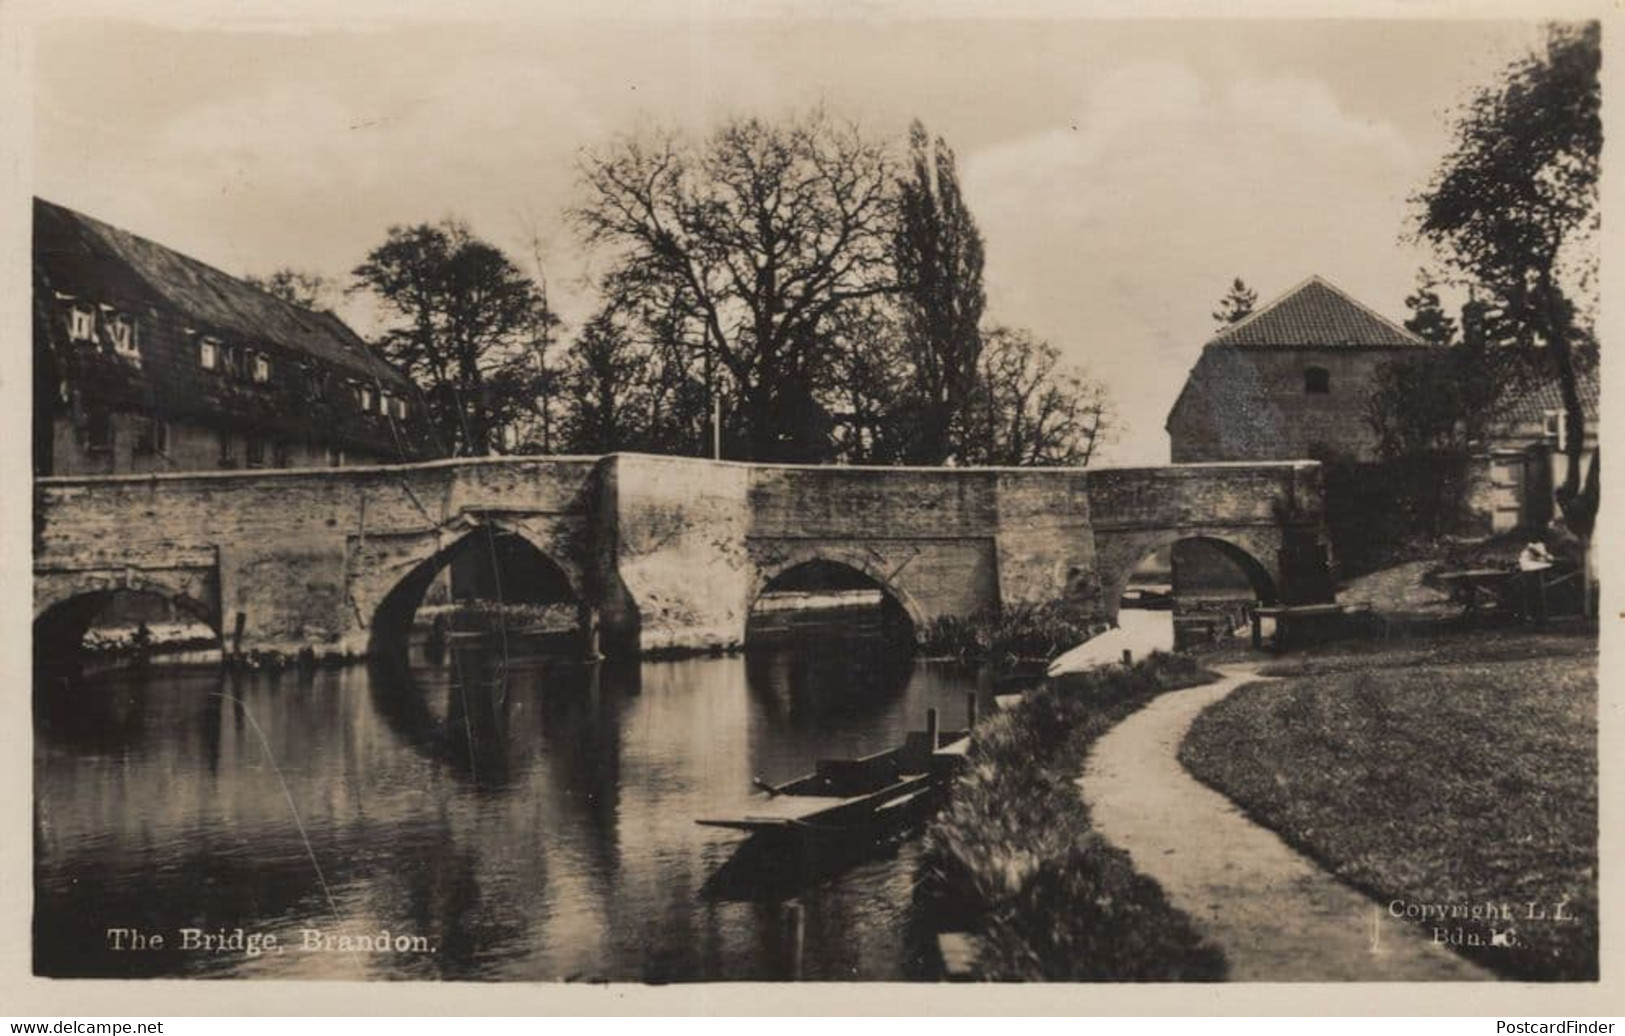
[918,654,1224,981]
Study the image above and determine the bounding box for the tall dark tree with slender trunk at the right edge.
[1415,21,1602,539]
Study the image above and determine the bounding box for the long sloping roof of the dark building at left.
[34,198,406,385]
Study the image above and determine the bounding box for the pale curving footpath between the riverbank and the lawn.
[1079,666,1493,982]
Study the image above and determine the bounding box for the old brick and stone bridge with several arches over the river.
[34,455,1331,653]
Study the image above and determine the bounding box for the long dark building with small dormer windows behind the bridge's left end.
[34,198,431,474]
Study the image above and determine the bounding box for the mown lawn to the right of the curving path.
[1180,633,1597,979]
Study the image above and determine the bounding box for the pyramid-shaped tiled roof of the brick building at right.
[1207,276,1428,349]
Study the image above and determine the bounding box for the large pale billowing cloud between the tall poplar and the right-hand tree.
[964,62,1419,463]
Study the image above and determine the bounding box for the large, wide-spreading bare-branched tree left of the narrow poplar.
[574,110,895,461]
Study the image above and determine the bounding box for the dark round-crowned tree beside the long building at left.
[349,219,554,456]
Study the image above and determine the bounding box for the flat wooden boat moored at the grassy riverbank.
[696,706,973,835]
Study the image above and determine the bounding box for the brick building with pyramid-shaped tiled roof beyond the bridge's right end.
[1167,276,1428,463]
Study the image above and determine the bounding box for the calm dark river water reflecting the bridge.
[34,630,1014,982]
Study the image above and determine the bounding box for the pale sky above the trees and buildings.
[33,15,1539,464]
